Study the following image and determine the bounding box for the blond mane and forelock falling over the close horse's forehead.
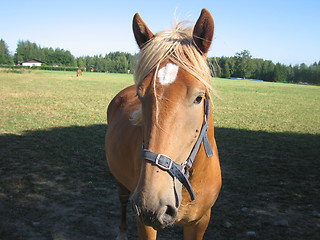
[131,22,212,125]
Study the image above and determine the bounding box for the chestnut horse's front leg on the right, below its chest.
[183,209,211,240]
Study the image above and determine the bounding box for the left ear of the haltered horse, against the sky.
[132,13,154,48]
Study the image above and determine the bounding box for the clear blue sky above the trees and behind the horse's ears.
[0,0,320,65]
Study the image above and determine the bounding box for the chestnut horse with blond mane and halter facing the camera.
[105,9,222,240]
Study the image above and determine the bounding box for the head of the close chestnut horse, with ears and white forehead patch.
[132,9,214,229]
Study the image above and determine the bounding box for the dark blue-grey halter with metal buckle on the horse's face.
[141,99,213,200]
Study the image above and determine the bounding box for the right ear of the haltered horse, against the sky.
[193,8,214,54]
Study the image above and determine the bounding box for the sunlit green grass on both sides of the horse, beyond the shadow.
[0,71,320,134]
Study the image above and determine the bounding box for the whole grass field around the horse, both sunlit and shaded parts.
[0,71,320,240]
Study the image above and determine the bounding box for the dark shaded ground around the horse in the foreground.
[0,125,320,240]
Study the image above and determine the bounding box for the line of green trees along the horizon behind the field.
[0,39,320,85]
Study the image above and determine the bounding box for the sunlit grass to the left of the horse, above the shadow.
[0,71,133,133]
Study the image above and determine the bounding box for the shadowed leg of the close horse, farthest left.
[117,183,130,240]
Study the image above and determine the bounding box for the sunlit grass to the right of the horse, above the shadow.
[214,79,320,134]
